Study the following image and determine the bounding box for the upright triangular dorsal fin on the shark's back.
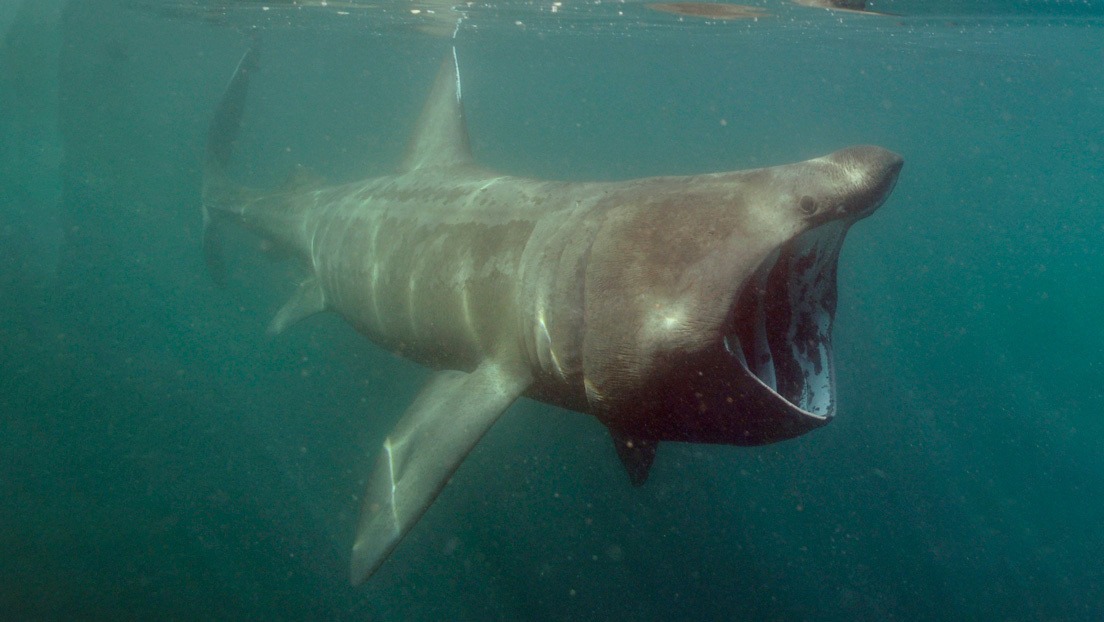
[402,48,473,172]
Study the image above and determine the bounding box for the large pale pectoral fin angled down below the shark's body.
[350,362,532,586]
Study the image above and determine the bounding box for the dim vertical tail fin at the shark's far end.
[203,39,258,285]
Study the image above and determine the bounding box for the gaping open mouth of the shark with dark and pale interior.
[724,221,851,419]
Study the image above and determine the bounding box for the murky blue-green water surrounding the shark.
[0,0,1104,621]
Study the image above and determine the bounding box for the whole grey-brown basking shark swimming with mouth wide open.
[203,43,903,584]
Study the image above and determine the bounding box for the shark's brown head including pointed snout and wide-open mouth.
[584,147,902,452]
